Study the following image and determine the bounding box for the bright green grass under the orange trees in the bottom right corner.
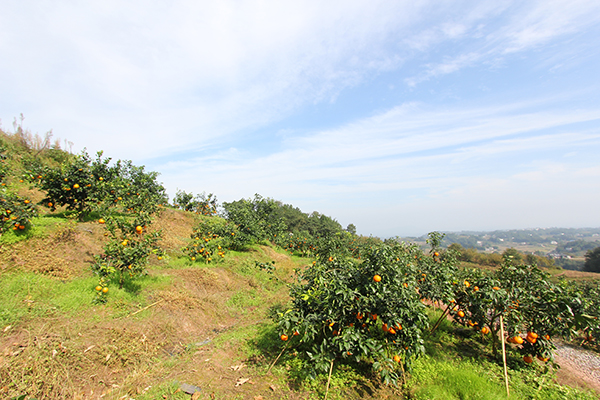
[406,311,596,400]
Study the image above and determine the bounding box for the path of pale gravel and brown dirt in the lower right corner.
[555,343,600,396]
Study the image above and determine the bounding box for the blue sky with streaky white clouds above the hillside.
[0,0,600,237]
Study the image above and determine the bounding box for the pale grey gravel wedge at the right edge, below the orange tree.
[555,343,600,394]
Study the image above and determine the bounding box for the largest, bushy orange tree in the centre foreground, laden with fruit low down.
[278,239,428,383]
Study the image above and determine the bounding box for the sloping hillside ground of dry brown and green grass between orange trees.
[0,129,597,400]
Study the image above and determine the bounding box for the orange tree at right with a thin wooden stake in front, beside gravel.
[454,256,593,362]
